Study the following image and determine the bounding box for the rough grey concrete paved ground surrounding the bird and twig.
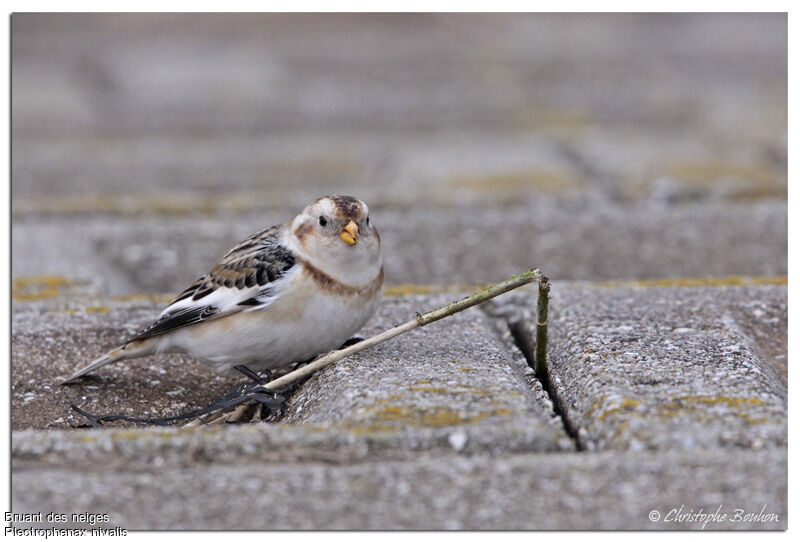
[11,14,788,529]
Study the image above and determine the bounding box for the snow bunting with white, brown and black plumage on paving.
[64,196,383,383]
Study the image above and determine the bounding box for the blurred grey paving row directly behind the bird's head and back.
[12,198,787,295]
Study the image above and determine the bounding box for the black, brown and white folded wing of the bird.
[131,226,296,341]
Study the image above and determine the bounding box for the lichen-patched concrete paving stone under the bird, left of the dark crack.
[12,295,574,451]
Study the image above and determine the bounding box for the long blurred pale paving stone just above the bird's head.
[13,134,593,206]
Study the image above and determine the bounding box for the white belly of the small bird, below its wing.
[159,274,382,373]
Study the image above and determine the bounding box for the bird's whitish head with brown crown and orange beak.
[290,196,381,286]
